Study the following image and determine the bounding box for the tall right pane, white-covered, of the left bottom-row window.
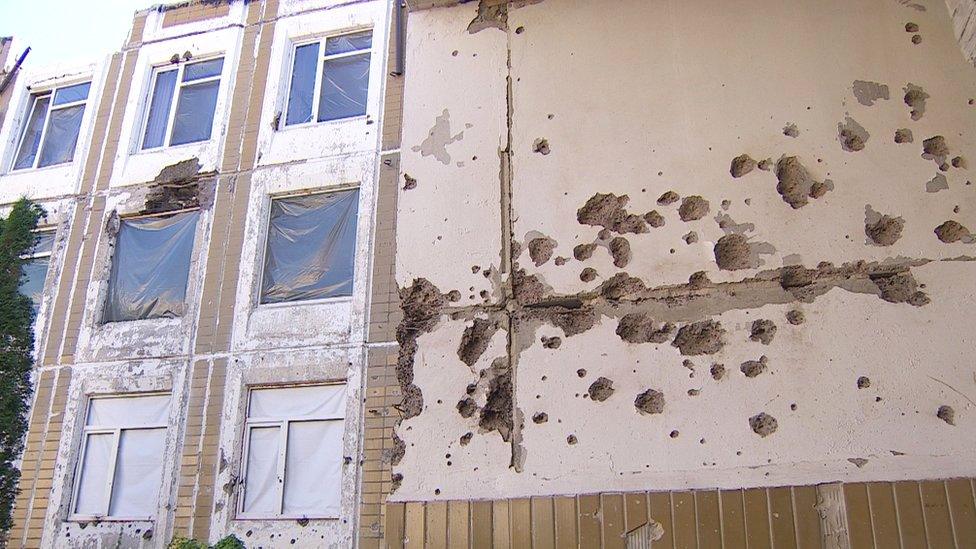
[109,429,166,518]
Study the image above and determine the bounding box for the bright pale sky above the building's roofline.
[0,0,158,67]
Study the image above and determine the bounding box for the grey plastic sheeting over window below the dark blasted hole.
[103,212,199,322]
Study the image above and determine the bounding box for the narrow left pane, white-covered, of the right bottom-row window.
[244,427,280,515]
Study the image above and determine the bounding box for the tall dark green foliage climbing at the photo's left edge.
[0,198,44,531]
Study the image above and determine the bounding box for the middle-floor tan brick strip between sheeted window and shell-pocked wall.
[368,153,403,343]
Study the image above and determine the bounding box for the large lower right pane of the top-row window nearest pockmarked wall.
[318,53,369,122]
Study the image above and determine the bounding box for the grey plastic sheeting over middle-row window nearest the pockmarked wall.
[261,189,359,303]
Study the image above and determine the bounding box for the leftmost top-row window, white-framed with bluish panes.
[14,82,91,170]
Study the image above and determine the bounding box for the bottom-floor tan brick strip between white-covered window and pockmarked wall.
[359,347,400,547]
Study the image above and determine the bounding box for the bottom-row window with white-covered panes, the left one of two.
[71,395,170,520]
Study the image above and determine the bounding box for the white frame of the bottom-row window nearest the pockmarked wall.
[236,381,346,520]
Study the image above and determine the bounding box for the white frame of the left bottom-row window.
[68,392,173,522]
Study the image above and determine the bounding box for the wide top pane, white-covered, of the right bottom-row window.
[247,385,346,419]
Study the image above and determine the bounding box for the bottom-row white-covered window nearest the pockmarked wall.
[239,385,346,518]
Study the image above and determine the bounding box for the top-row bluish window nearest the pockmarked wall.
[285,31,373,126]
